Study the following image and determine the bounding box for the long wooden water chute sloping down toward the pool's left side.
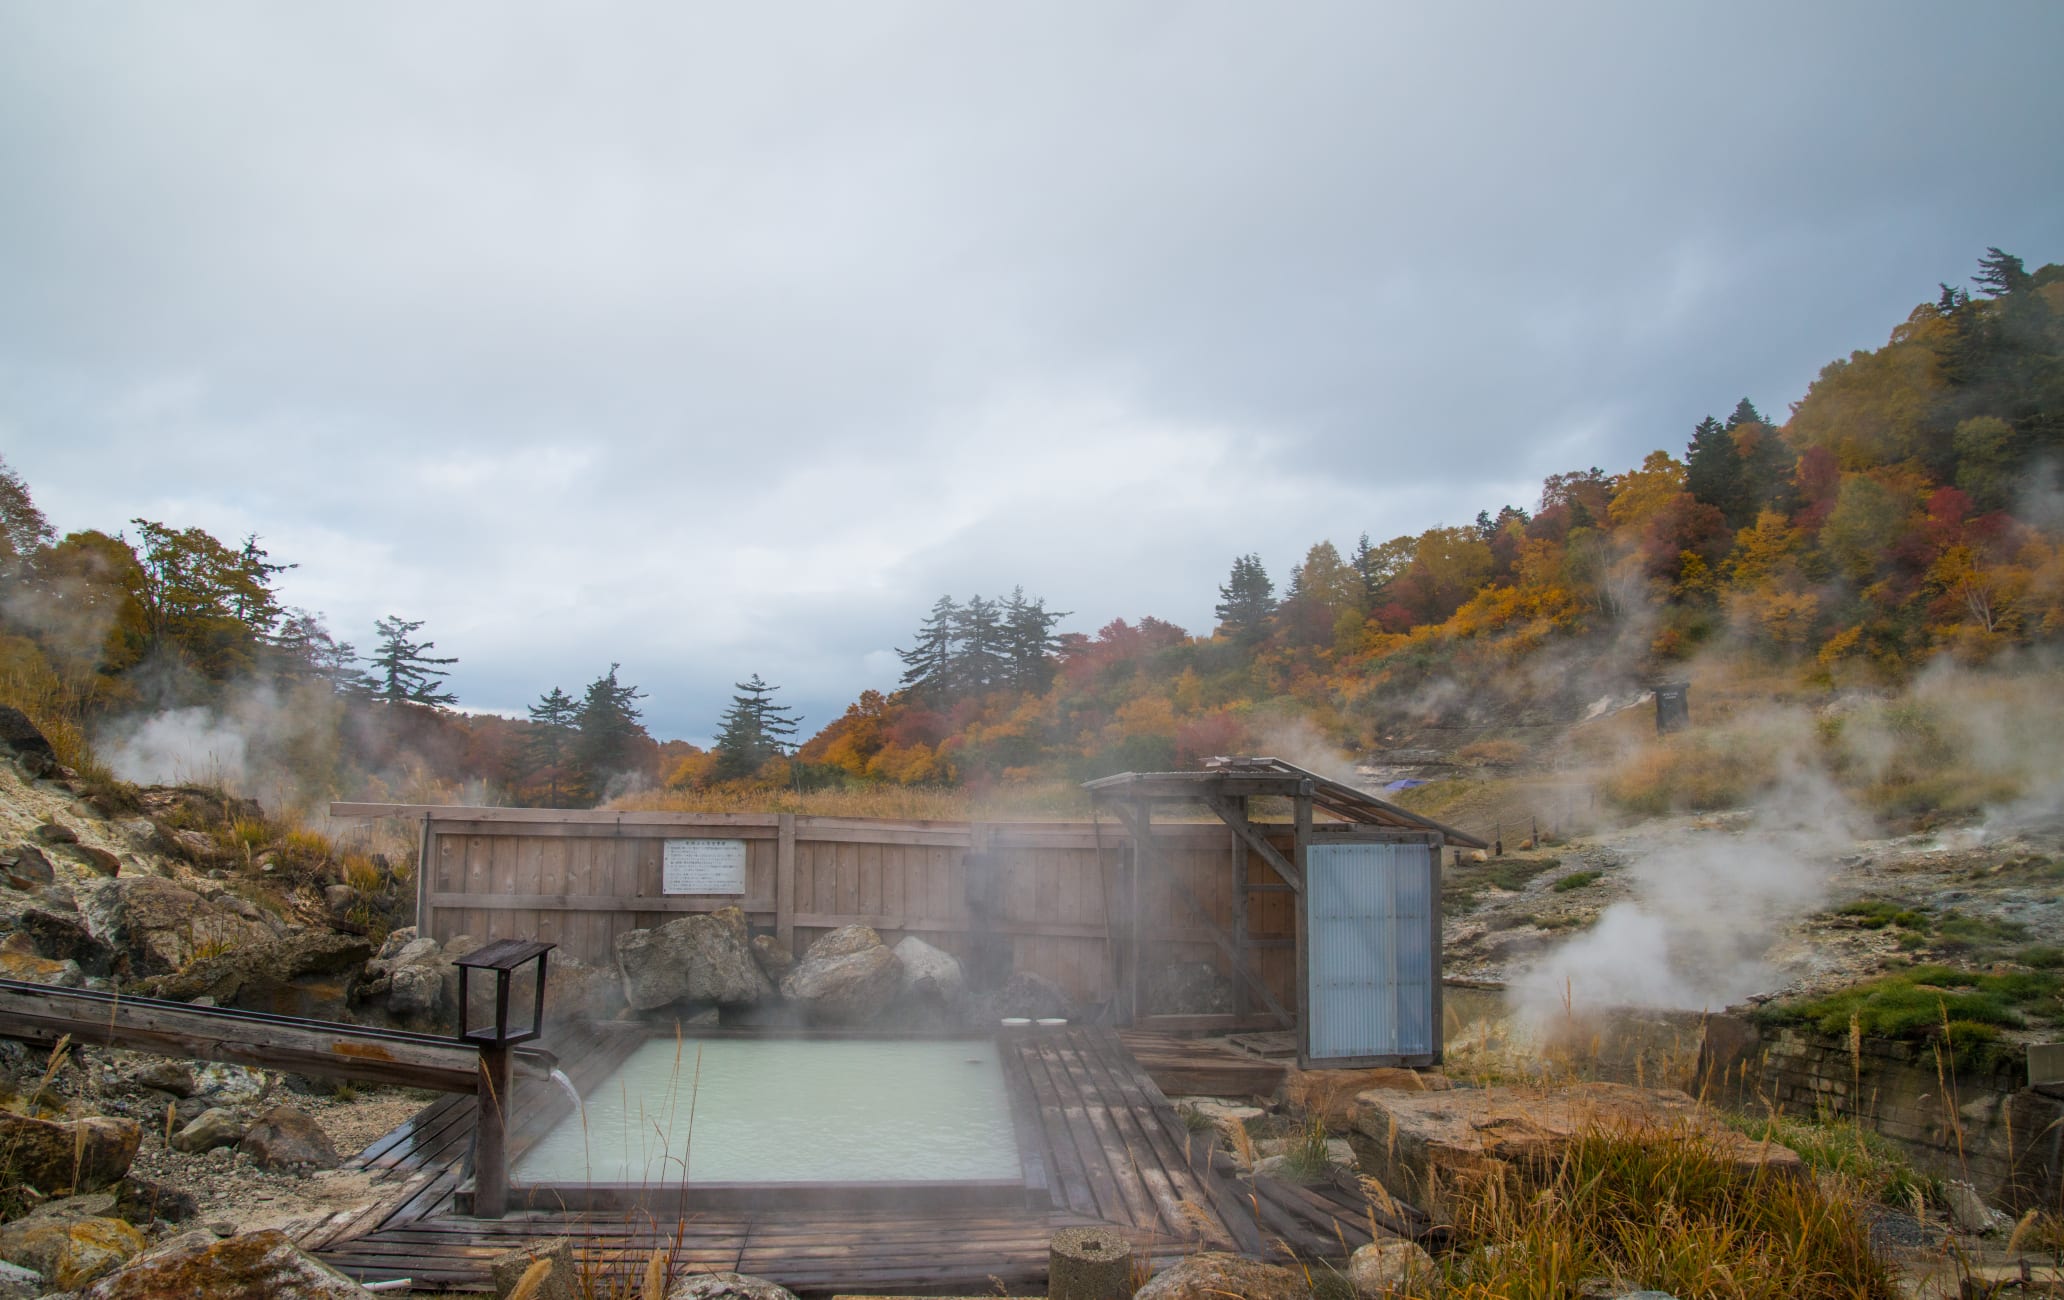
[0,980,553,1092]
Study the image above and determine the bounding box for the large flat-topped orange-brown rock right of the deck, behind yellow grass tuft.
[1354,1083,1806,1217]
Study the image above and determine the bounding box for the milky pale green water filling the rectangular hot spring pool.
[512,1038,1022,1187]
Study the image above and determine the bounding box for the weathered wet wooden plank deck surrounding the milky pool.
[299,1026,1426,1294]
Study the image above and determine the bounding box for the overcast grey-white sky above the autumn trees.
[0,0,2064,739]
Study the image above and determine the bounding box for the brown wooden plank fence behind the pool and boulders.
[332,803,1296,1019]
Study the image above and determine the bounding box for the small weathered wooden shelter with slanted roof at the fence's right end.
[1084,757,1488,1065]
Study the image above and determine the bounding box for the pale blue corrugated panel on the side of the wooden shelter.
[1304,844,1441,1061]
